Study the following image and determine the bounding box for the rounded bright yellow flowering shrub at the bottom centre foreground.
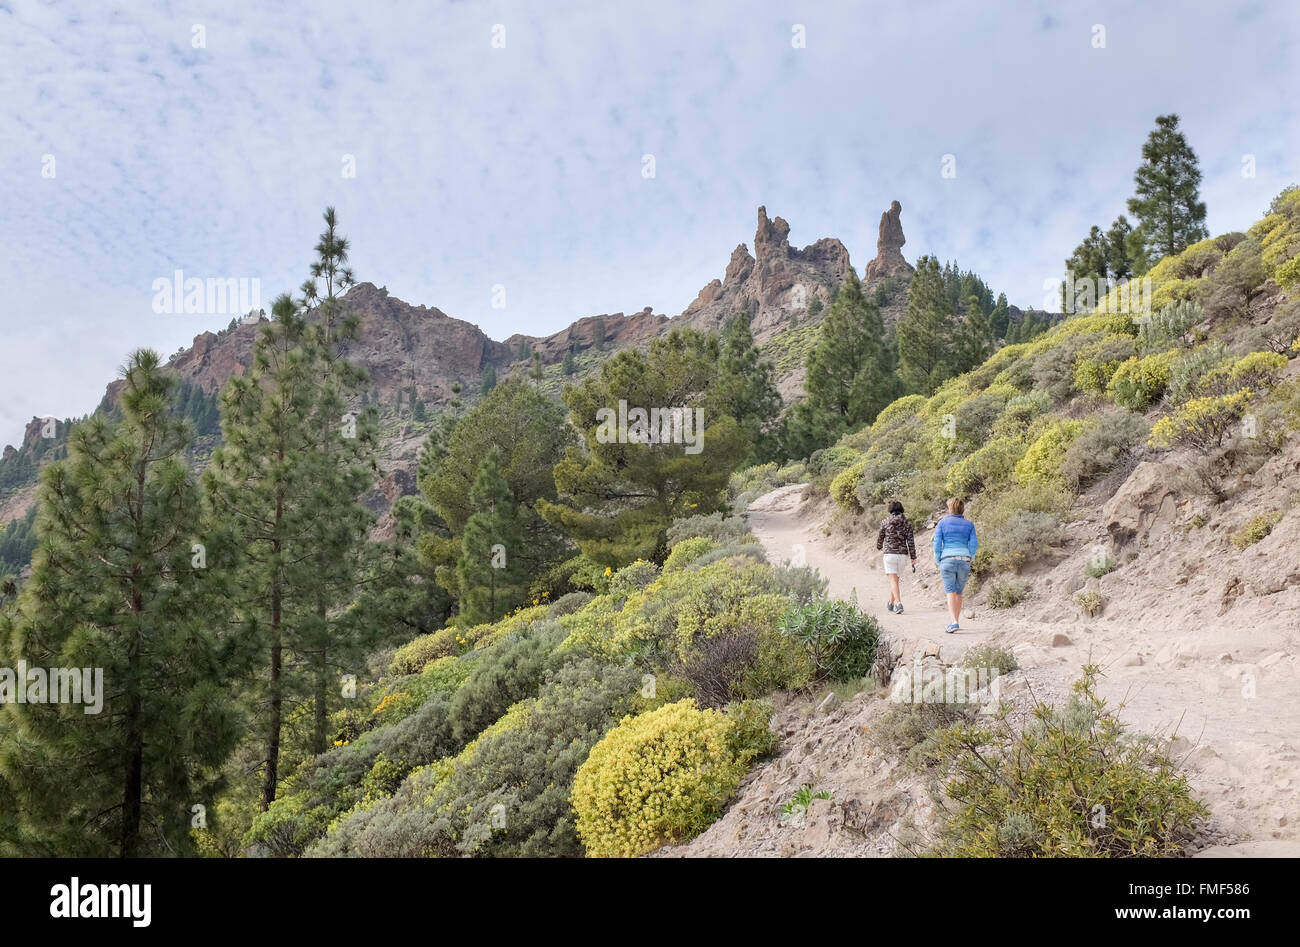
[571,699,745,857]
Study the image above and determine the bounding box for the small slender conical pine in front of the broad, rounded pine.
[456,449,528,627]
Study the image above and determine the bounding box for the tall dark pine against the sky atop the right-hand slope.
[1128,114,1209,259]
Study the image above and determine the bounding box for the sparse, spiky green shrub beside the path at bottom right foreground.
[928,666,1209,857]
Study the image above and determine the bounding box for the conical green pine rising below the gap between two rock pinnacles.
[792,269,894,455]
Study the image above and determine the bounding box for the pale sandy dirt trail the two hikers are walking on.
[749,485,1300,855]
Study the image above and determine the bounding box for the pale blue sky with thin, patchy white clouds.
[0,0,1300,444]
